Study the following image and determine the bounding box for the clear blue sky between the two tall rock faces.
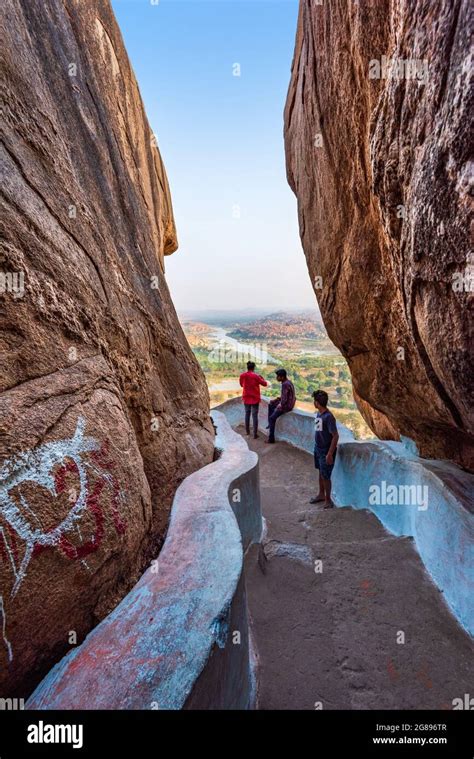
[112,0,316,312]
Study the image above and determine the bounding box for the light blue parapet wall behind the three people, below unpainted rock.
[217,398,474,635]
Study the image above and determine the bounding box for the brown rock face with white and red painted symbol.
[0,0,214,697]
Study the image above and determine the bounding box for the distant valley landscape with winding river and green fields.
[181,310,373,439]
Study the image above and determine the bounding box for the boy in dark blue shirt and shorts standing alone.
[310,390,339,509]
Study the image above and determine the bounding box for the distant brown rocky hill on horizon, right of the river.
[229,311,327,340]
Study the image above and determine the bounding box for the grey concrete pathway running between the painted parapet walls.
[243,430,474,709]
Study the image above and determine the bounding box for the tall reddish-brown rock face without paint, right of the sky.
[285,0,474,469]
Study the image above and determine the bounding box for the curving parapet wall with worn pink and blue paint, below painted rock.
[26,412,262,709]
